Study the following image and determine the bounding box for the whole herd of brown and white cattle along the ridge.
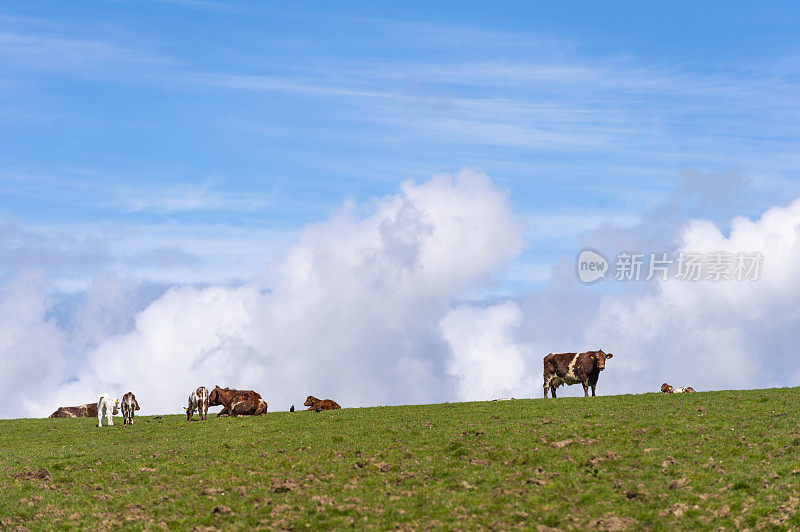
[50,349,695,427]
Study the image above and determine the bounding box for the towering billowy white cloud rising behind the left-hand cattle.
[14,171,522,415]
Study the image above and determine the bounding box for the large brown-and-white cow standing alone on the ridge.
[544,349,614,398]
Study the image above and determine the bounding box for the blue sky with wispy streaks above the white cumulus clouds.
[6,1,800,294]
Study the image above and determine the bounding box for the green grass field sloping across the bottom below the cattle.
[0,388,800,530]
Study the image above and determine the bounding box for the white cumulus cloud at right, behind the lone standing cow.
[529,192,800,393]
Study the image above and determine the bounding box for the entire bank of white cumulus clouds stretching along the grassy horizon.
[0,171,800,417]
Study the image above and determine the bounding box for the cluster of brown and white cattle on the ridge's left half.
[50,386,342,427]
